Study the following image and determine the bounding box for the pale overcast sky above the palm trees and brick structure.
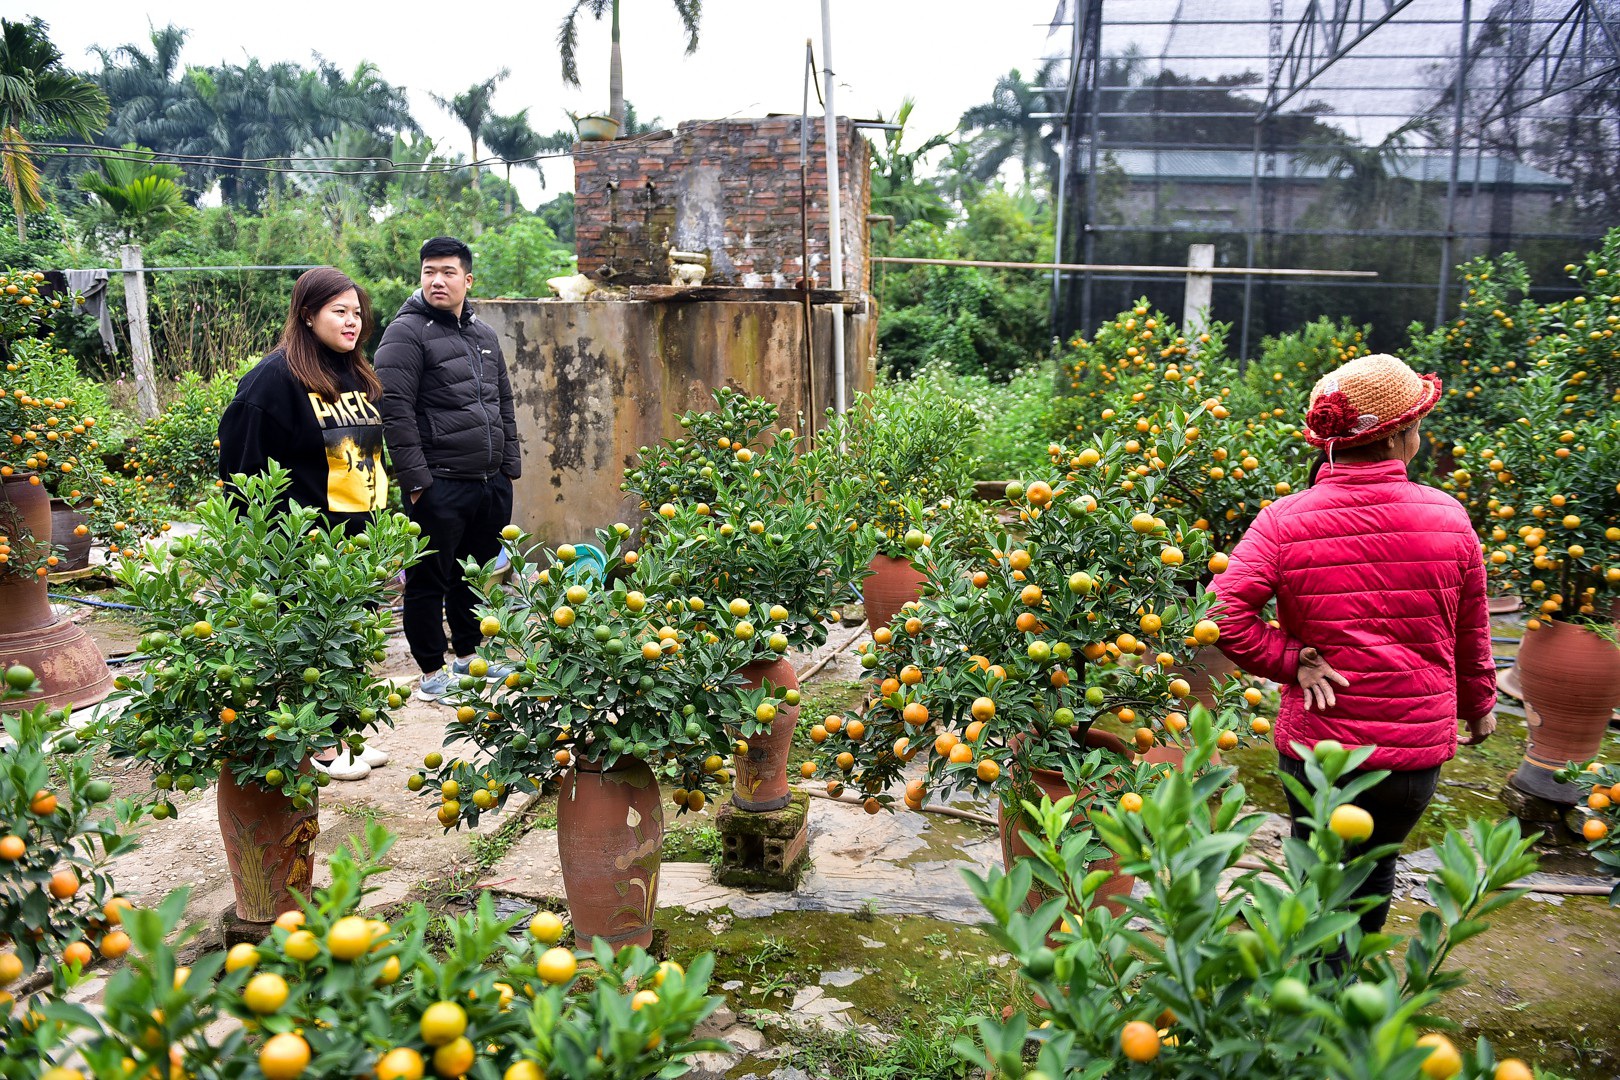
[31,0,1066,206]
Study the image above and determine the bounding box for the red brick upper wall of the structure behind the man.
[573,117,872,293]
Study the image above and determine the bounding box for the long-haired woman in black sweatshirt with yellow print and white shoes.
[219,266,389,780]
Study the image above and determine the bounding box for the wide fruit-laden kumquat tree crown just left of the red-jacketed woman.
[810,404,1268,913]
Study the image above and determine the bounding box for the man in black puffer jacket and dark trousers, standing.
[376,236,523,701]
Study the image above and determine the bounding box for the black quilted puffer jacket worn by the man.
[376,291,523,492]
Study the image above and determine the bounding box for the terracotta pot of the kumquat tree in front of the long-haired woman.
[215,764,321,923]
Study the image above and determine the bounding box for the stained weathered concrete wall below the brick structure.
[478,300,876,542]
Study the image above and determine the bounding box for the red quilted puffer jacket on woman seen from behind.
[1210,461,1497,769]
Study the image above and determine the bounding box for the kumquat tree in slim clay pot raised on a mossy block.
[625,387,865,811]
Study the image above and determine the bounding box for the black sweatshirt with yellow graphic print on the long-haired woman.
[219,350,389,531]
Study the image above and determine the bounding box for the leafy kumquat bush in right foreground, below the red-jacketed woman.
[956,722,1550,1080]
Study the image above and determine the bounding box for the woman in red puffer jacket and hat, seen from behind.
[1210,355,1497,933]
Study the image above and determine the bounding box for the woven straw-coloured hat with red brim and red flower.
[1306,353,1440,449]
